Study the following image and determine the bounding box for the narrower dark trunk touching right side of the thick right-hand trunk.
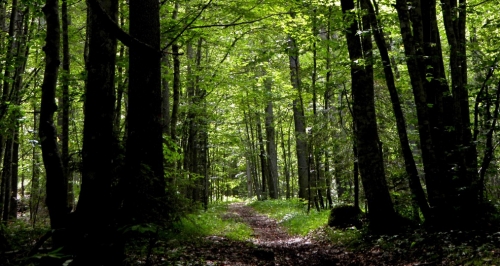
[441,0,476,212]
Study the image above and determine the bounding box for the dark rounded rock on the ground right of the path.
[328,205,363,229]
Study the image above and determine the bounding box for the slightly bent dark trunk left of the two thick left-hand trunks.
[39,0,68,247]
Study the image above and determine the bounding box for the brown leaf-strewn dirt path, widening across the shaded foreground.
[161,203,430,266]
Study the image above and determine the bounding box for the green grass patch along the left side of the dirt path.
[169,202,253,241]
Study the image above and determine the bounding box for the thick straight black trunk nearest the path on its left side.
[124,0,165,220]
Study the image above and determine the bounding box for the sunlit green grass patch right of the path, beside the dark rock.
[249,199,330,236]
